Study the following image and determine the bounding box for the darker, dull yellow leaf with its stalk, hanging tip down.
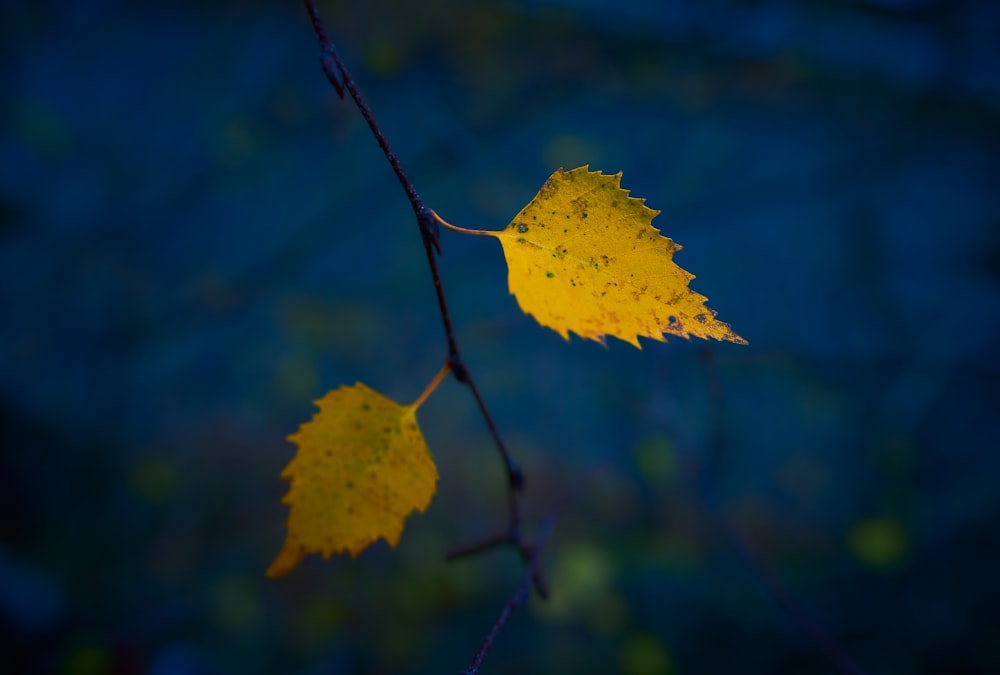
[267,382,438,578]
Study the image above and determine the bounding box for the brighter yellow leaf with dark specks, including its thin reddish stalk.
[442,166,746,348]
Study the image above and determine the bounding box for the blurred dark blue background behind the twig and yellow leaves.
[0,0,1000,675]
